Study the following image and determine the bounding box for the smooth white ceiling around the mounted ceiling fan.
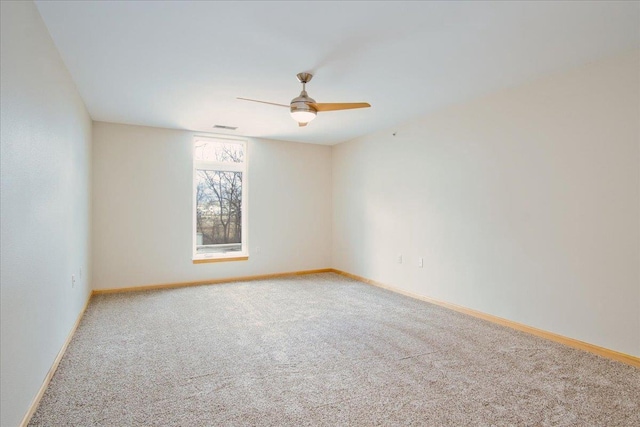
[36,1,640,144]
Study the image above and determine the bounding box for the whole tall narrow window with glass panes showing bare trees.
[193,137,248,263]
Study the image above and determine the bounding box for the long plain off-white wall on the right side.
[333,51,640,356]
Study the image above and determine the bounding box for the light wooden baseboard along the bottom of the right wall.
[331,269,640,368]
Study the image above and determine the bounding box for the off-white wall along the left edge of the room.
[0,1,91,426]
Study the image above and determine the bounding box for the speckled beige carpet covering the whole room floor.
[30,273,640,426]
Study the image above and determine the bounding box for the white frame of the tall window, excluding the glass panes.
[191,135,249,264]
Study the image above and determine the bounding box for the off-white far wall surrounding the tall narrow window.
[92,122,332,289]
